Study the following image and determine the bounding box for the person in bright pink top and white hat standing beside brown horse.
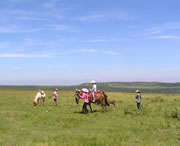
[80,88,89,114]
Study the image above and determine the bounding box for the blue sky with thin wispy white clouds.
[0,0,180,85]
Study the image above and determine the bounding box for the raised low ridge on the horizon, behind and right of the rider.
[81,82,180,94]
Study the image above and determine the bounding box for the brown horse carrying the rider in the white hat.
[74,89,109,107]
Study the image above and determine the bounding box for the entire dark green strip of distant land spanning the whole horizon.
[0,82,180,94]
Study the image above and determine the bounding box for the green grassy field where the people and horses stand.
[0,90,180,146]
